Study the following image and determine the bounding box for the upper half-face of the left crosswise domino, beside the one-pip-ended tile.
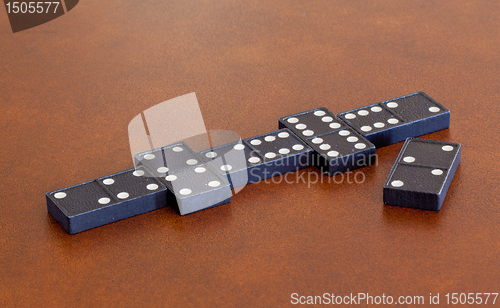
[134,142,202,177]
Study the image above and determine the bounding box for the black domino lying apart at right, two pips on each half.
[384,138,461,211]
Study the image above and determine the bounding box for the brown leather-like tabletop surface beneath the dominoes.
[0,0,500,307]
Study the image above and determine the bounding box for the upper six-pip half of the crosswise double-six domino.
[278,107,345,140]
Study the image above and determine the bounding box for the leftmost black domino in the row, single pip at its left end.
[47,169,167,234]
